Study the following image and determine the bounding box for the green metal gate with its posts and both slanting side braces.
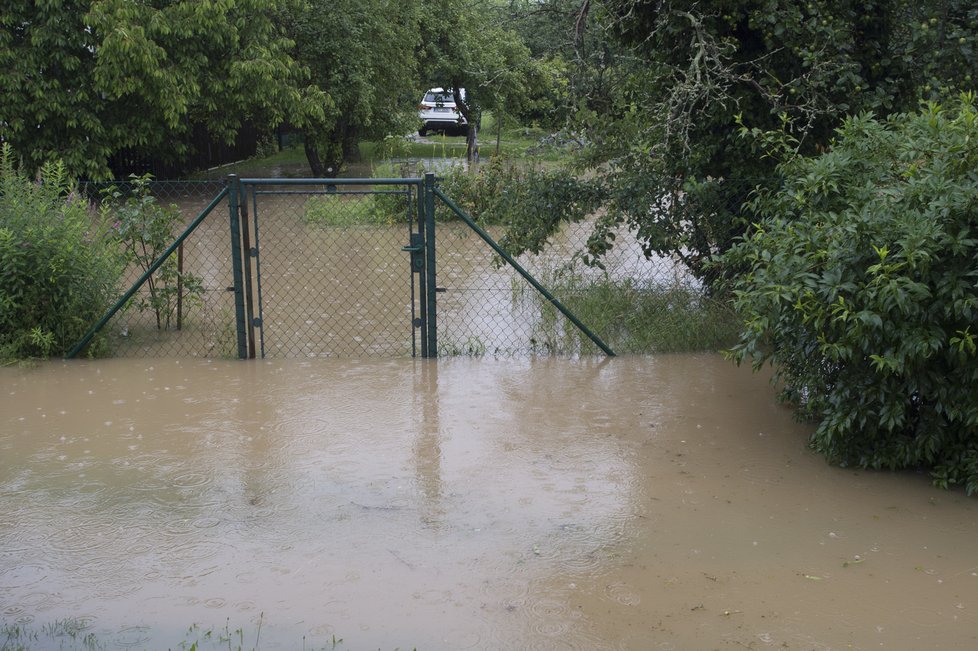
[66,174,614,359]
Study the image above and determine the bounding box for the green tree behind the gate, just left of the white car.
[282,0,420,177]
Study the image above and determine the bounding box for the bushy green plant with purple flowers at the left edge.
[0,143,122,361]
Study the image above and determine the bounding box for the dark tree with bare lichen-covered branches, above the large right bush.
[508,0,978,278]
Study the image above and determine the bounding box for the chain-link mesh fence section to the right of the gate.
[438,182,755,357]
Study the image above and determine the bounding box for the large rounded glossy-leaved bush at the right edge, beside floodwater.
[727,96,978,494]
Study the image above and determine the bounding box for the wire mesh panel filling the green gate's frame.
[242,185,417,357]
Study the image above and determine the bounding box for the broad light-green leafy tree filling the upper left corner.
[0,0,322,179]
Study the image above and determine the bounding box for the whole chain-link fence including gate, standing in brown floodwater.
[72,180,752,358]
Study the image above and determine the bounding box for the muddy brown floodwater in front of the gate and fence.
[0,355,978,650]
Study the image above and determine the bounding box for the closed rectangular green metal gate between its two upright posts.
[229,177,436,358]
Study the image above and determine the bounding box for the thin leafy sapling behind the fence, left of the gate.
[105,176,204,330]
